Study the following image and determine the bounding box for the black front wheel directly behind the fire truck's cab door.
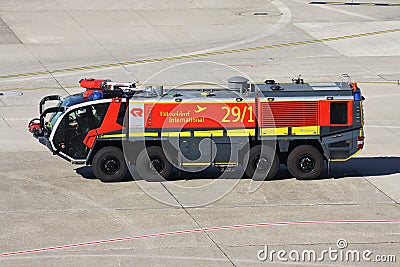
[92,146,128,182]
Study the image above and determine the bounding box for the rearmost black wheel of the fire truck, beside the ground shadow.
[287,145,324,180]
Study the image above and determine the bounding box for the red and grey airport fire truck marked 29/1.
[29,75,364,182]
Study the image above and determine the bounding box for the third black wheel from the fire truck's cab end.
[245,145,279,181]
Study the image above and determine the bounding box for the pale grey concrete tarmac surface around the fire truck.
[0,0,400,266]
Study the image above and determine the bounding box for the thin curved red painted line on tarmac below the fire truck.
[0,220,400,257]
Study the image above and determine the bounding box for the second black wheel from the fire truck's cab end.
[136,146,172,182]
